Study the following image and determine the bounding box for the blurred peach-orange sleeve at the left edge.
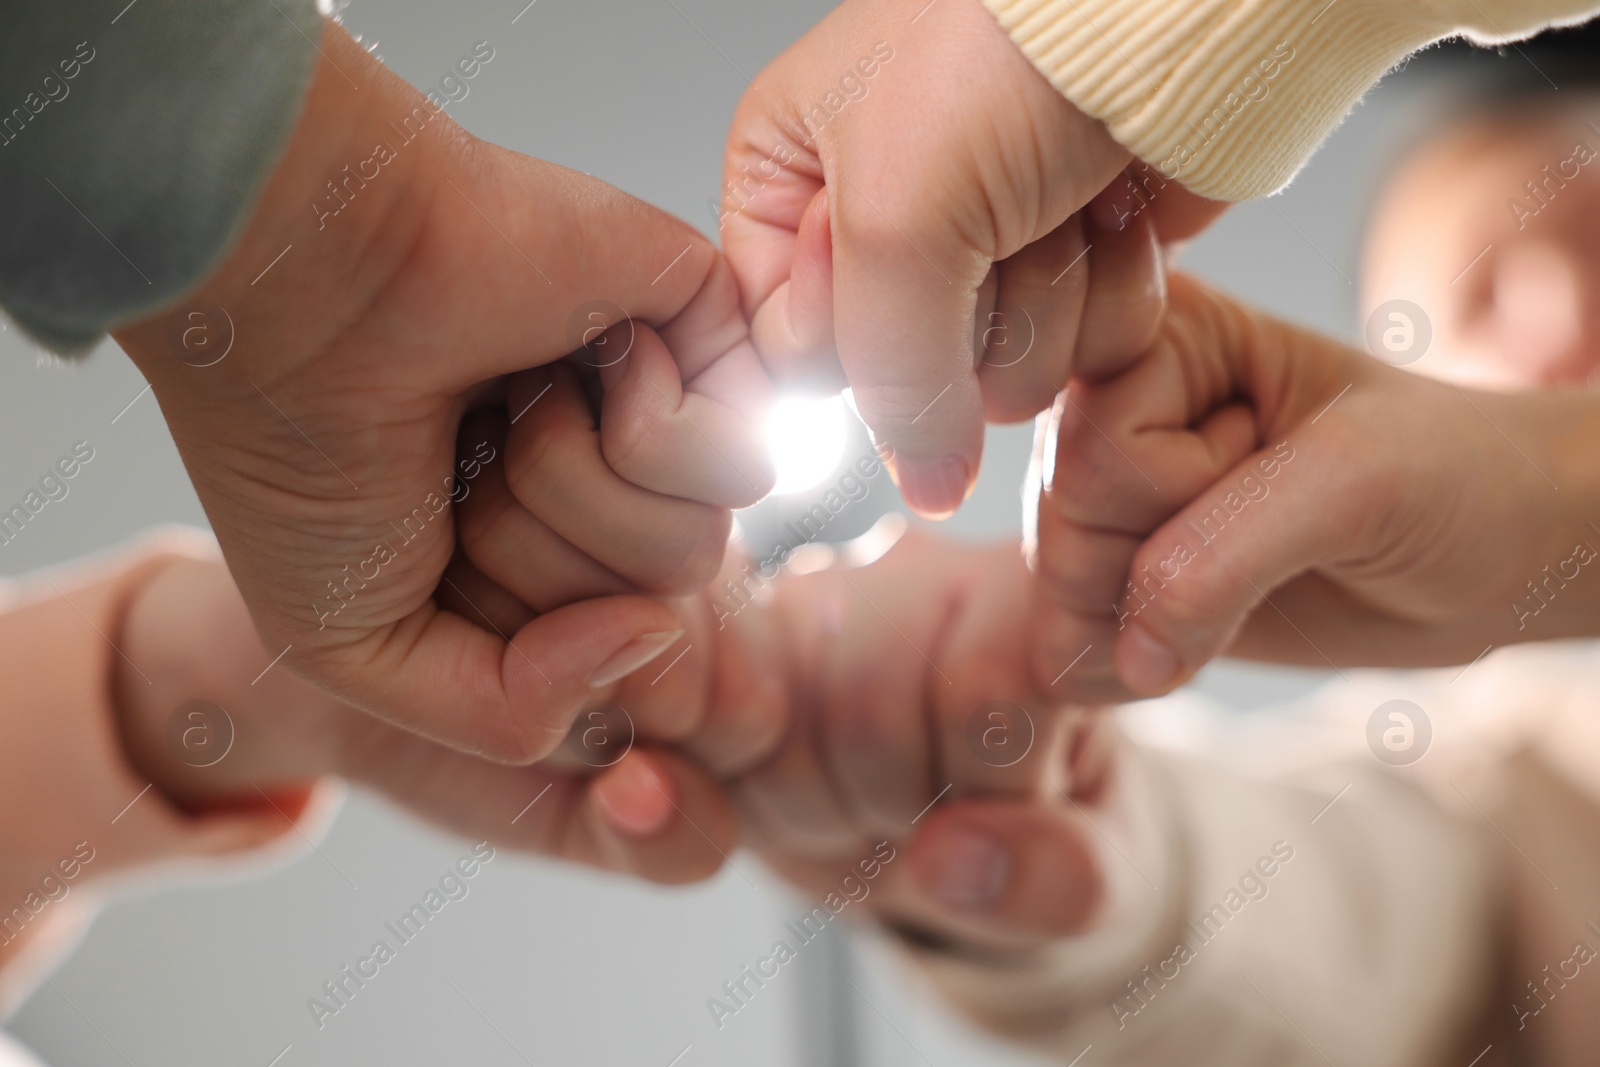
[0,533,339,1017]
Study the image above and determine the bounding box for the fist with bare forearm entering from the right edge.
[1034,277,1600,699]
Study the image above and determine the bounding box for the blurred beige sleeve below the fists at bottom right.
[907,739,1498,1067]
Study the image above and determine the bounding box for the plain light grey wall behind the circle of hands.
[0,0,1446,1067]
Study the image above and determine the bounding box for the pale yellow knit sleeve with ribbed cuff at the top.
[986,0,1600,200]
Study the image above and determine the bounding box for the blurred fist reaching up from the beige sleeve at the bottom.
[723,534,1114,950]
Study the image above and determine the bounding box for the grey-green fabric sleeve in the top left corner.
[0,0,322,354]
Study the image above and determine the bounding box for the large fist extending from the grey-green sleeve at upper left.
[117,22,771,761]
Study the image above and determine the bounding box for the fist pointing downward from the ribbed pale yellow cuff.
[720,0,1177,517]
